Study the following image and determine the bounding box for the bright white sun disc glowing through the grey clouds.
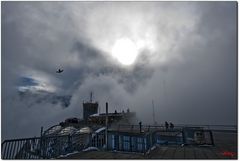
[112,38,138,65]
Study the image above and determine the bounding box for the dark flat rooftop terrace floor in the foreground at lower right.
[61,131,237,159]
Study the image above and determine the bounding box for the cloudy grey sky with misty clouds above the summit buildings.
[1,2,237,139]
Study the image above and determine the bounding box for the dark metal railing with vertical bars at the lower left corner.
[1,134,90,159]
